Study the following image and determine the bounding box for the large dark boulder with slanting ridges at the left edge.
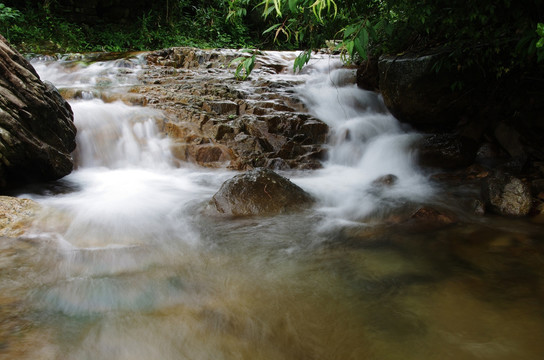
[0,36,76,188]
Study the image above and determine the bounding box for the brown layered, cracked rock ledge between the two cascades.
[135,48,329,170]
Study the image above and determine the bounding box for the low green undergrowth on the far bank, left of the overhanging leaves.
[0,0,254,52]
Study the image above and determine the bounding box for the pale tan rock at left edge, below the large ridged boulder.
[0,196,40,237]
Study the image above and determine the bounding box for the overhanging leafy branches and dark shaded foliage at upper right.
[230,0,544,77]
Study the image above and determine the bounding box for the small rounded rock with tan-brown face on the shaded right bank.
[482,173,532,217]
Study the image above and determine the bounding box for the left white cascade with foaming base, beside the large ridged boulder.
[28,56,217,249]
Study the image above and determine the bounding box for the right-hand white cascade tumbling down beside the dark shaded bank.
[298,60,433,222]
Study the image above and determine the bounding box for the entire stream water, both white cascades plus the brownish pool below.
[0,55,544,360]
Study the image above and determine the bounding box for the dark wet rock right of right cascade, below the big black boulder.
[416,134,477,169]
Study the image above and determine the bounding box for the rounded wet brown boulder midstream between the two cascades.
[212,168,313,216]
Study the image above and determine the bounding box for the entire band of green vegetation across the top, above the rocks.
[0,0,544,78]
